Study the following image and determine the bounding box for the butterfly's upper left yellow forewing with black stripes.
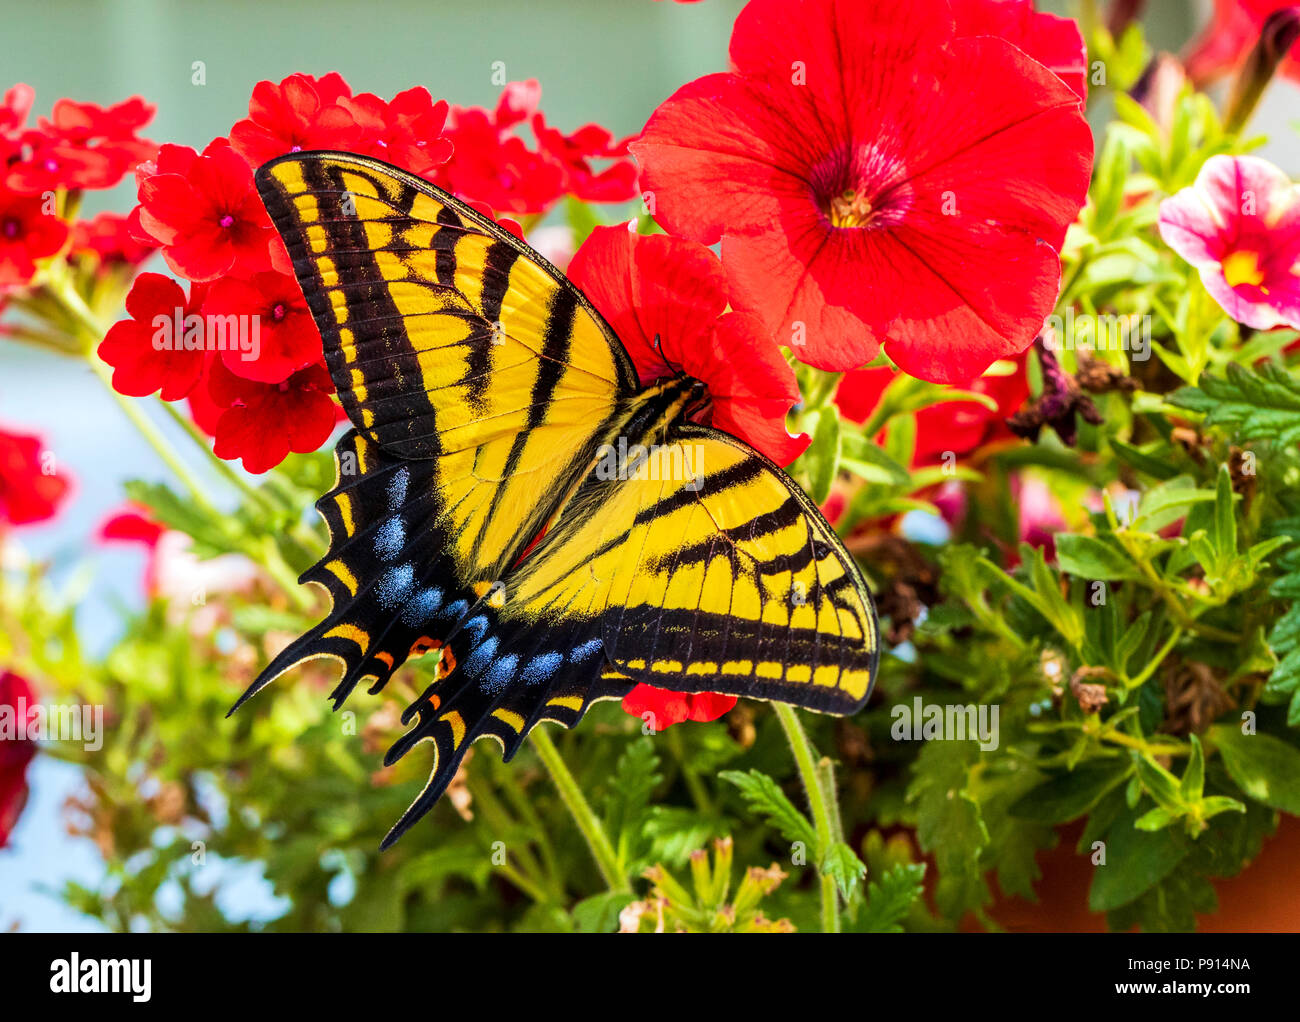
[257,153,637,583]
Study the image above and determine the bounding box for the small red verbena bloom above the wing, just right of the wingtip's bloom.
[338,87,451,177]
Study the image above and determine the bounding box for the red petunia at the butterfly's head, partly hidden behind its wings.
[568,228,809,465]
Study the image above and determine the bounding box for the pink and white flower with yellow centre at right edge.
[1160,156,1300,330]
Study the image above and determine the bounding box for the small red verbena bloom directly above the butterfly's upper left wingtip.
[230,72,364,168]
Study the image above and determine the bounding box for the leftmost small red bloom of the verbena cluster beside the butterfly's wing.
[99,273,208,400]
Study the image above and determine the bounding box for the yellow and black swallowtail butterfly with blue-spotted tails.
[231,152,879,848]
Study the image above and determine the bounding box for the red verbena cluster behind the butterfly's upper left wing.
[99,73,636,472]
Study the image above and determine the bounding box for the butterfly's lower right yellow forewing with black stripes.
[503,425,879,714]
